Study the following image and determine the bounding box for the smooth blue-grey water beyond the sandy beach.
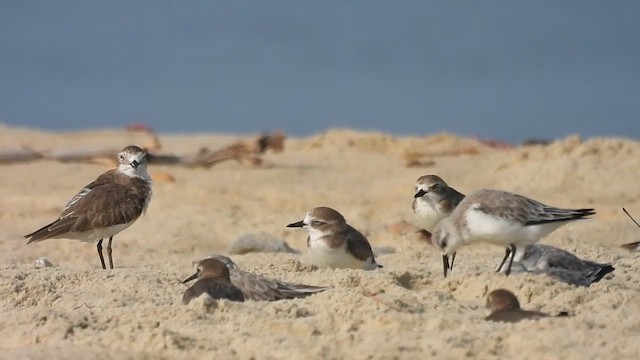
[0,0,640,142]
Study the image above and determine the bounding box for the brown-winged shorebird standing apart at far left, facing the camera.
[25,145,151,269]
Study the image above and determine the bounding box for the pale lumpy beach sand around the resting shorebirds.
[0,126,640,359]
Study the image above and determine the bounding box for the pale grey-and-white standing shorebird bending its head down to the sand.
[432,189,595,277]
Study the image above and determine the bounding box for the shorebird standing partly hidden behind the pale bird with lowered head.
[411,175,464,268]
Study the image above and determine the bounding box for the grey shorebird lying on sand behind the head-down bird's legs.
[498,244,615,286]
